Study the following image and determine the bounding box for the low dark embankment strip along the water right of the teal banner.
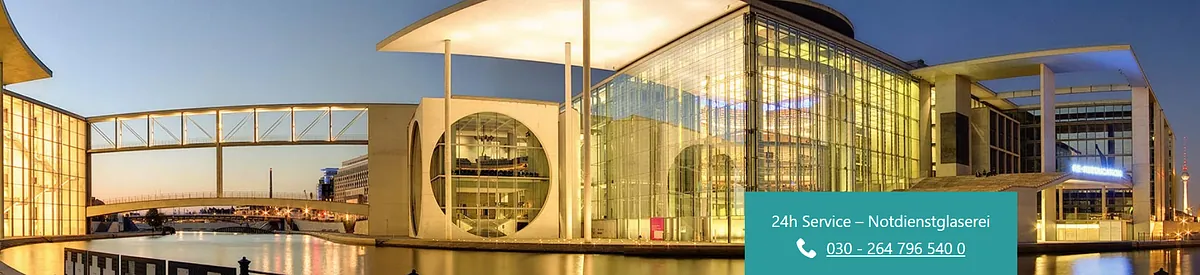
[1016,240,1200,255]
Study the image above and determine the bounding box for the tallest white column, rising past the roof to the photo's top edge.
[581,0,592,241]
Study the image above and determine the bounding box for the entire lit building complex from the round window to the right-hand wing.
[372,0,1174,243]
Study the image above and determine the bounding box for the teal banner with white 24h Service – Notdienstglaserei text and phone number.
[745,192,1016,275]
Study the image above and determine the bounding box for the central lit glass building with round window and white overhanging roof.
[379,0,928,243]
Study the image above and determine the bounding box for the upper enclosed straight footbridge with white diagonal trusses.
[88,103,404,154]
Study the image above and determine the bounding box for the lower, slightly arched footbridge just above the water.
[86,192,368,217]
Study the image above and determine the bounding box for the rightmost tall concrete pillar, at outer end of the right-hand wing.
[1132,86,1153,238]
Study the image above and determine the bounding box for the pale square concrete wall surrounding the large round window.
[412,97,560,239]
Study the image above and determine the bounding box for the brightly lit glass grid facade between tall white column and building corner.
[589,14,746,241]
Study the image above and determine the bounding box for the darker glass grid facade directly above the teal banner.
[754,16,924,192]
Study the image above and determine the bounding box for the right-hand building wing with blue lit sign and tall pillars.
[912,44,1178,241]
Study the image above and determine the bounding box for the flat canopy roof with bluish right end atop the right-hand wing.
[911,44,1150,86]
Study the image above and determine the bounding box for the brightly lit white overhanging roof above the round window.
[376,0,746,70]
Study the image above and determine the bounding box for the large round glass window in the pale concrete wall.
[430,113,550,237]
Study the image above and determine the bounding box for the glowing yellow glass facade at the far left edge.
[2,91,88,238]
